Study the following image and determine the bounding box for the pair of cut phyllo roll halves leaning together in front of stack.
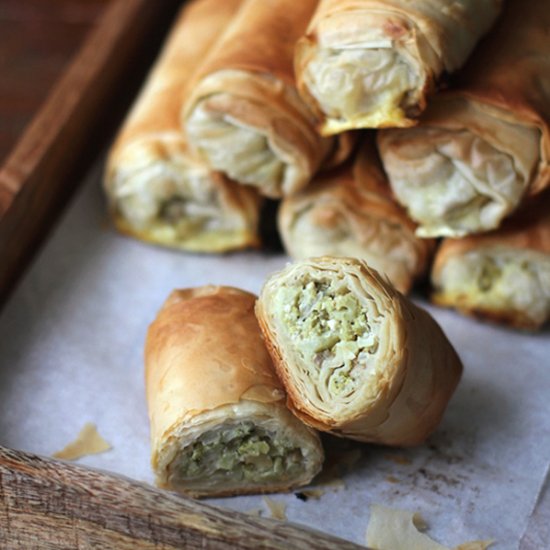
[145,268,462,497]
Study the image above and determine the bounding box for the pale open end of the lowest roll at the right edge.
[438,248,550,324]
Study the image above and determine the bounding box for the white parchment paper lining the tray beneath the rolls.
[0,162,550,550]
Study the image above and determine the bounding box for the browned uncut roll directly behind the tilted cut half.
[279,138,435,293]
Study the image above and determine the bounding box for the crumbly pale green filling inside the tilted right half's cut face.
[277,281,378,396]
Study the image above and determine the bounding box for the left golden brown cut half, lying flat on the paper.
[145,286,323,496]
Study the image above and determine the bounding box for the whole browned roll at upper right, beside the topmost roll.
[378,0,550,237]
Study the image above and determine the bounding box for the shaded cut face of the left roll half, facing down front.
[163,402,320,494]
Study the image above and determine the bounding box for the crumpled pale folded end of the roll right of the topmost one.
[381,101,539,237]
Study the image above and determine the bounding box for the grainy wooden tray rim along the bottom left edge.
[0,447,364,550]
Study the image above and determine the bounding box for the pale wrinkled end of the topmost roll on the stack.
[303,12,427,133]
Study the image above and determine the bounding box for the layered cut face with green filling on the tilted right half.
[267,269,397,423]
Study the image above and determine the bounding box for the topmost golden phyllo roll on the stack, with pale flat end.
[296,0,502,135]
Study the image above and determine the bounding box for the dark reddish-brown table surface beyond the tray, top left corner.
[0,0,108,164]
